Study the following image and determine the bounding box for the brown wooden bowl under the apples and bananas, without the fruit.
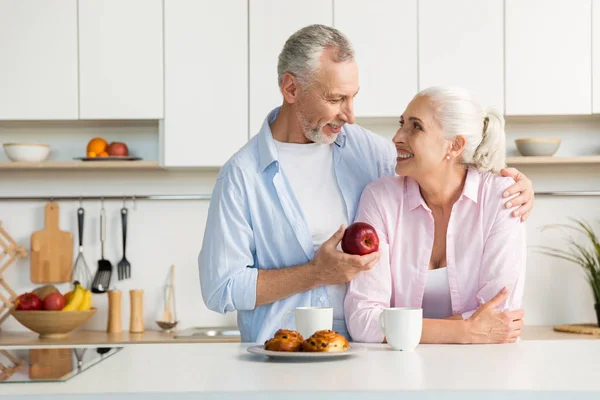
[11,307,96,339]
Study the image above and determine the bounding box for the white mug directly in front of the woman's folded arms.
[379,307,423,351]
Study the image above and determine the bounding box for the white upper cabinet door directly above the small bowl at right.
[505,0,592,115]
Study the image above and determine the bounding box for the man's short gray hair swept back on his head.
[277,25,354,87]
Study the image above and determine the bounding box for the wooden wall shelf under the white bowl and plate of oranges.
[0,160,162,170]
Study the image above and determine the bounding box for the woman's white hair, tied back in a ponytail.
[415,86,506,172]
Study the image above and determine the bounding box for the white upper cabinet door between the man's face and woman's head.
[334,0,417,117]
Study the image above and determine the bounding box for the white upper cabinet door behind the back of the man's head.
[249,0,333,136]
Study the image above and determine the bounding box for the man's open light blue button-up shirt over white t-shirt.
[198,108,396,343]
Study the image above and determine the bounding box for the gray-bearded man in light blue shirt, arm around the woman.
[198,25,533,342]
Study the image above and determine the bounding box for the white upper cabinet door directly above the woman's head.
[419,0,504,110]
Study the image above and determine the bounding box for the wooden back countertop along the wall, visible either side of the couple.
[0,326,600,349]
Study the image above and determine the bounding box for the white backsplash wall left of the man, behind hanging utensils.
[0,171,235,330]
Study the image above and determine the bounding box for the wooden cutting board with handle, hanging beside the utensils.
[31,203,73,283]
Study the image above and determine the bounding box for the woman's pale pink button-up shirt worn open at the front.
[344,169,526,343]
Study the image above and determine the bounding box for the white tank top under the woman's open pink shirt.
[422,267,452,319]
